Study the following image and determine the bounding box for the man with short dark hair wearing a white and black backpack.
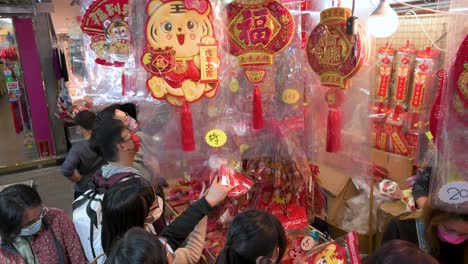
[73,109,148,263]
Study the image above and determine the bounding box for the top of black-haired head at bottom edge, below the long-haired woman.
[105,227,167,264]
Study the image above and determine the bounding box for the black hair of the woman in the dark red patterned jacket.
[0,184,42,243]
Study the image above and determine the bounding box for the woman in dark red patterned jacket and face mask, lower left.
[0,184,86,264]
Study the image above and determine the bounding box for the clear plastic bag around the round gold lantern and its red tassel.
[305,6,375,184]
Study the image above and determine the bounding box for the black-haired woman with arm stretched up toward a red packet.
[101,174,232,264]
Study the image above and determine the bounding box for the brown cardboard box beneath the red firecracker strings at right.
[370,148,413,190]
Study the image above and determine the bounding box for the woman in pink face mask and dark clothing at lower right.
[382,205,468,264]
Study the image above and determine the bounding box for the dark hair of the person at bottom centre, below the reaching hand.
[216,210,286,264]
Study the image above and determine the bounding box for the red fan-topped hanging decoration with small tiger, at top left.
[81,0,130,67]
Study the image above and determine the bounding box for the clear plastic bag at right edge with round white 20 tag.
[429,1,468,214]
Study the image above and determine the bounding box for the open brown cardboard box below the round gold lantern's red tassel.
[318,164,359,226]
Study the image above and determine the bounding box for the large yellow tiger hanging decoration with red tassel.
[141,0,219,151]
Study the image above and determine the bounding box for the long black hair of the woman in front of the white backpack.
[101,178,155,254]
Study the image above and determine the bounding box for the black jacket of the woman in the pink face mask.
[382,218,468,264]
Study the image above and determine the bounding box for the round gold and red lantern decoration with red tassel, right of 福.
[306,7,369,152]
